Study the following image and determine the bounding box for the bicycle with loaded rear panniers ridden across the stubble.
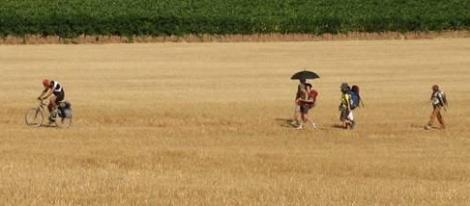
[25,101,72,128]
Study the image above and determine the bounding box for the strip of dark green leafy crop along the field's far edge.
[0,0,470,37]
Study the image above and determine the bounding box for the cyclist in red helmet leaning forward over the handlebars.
[38,79,65,122]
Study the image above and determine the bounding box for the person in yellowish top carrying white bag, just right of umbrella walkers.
[339,83,354,129]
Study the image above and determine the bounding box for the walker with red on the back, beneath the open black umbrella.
[296,83,318,129]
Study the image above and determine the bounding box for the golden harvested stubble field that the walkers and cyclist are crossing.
[0,39,470,205]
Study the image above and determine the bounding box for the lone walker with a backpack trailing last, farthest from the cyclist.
[425,85,448,129]
